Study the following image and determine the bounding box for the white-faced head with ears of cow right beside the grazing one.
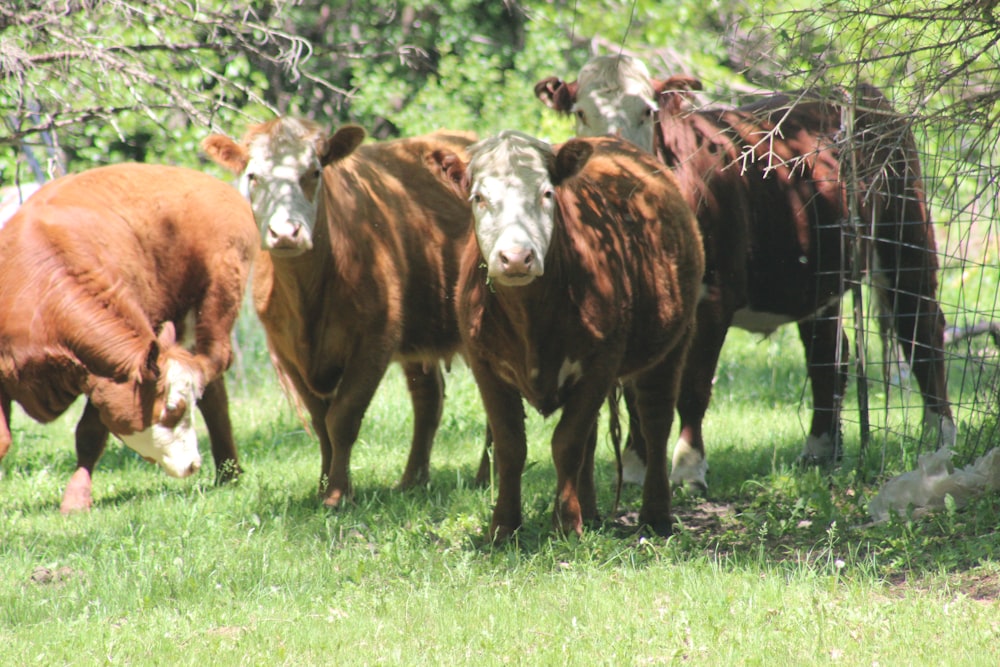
[202,118,365,257]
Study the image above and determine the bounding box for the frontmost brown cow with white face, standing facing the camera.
[441,131,704,541]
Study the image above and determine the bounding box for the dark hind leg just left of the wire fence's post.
[799,306,848,464]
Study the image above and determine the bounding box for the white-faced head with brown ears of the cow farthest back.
[535,55,701,153]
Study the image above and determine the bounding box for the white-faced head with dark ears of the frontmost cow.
[438,130,592,287]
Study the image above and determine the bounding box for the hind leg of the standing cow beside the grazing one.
[399,363,444,489]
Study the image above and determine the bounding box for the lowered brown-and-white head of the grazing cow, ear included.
[89,322,204,477]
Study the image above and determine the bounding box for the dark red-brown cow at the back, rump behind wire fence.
[535,56,956,490]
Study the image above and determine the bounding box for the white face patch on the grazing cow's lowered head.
[118,359,203,477]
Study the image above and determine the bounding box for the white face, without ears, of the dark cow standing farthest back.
[571,56,657,153]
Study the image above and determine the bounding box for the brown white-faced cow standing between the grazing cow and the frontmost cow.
[203,118,472,507]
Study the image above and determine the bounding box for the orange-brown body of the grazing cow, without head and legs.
[0,164,258,421]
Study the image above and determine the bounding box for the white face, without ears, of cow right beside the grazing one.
[239,130,323,256]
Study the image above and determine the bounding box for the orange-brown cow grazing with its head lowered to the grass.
[0,164,258,512]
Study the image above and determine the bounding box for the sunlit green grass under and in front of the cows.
[0,322,1000,665]
